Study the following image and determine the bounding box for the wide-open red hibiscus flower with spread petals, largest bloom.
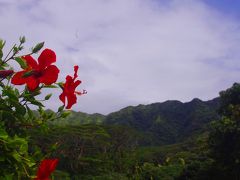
[11,49,59,91]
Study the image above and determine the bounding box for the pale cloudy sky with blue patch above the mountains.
[0,0,240,114]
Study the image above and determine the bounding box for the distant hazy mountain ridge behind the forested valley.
[54,98,220,145]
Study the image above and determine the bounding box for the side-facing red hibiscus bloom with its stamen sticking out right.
[59,66,86,109]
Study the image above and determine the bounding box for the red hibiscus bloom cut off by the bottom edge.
[35,159,58,180]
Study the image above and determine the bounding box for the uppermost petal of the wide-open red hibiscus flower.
[38,49,56,69]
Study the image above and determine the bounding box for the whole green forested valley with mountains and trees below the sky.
[30,83,240,180]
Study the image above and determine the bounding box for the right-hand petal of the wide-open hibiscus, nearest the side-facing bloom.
[39,65,59,85]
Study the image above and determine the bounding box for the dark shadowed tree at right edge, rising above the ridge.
[209,83,240,179]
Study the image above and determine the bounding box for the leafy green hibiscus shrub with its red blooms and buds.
[0,37,86,180]
